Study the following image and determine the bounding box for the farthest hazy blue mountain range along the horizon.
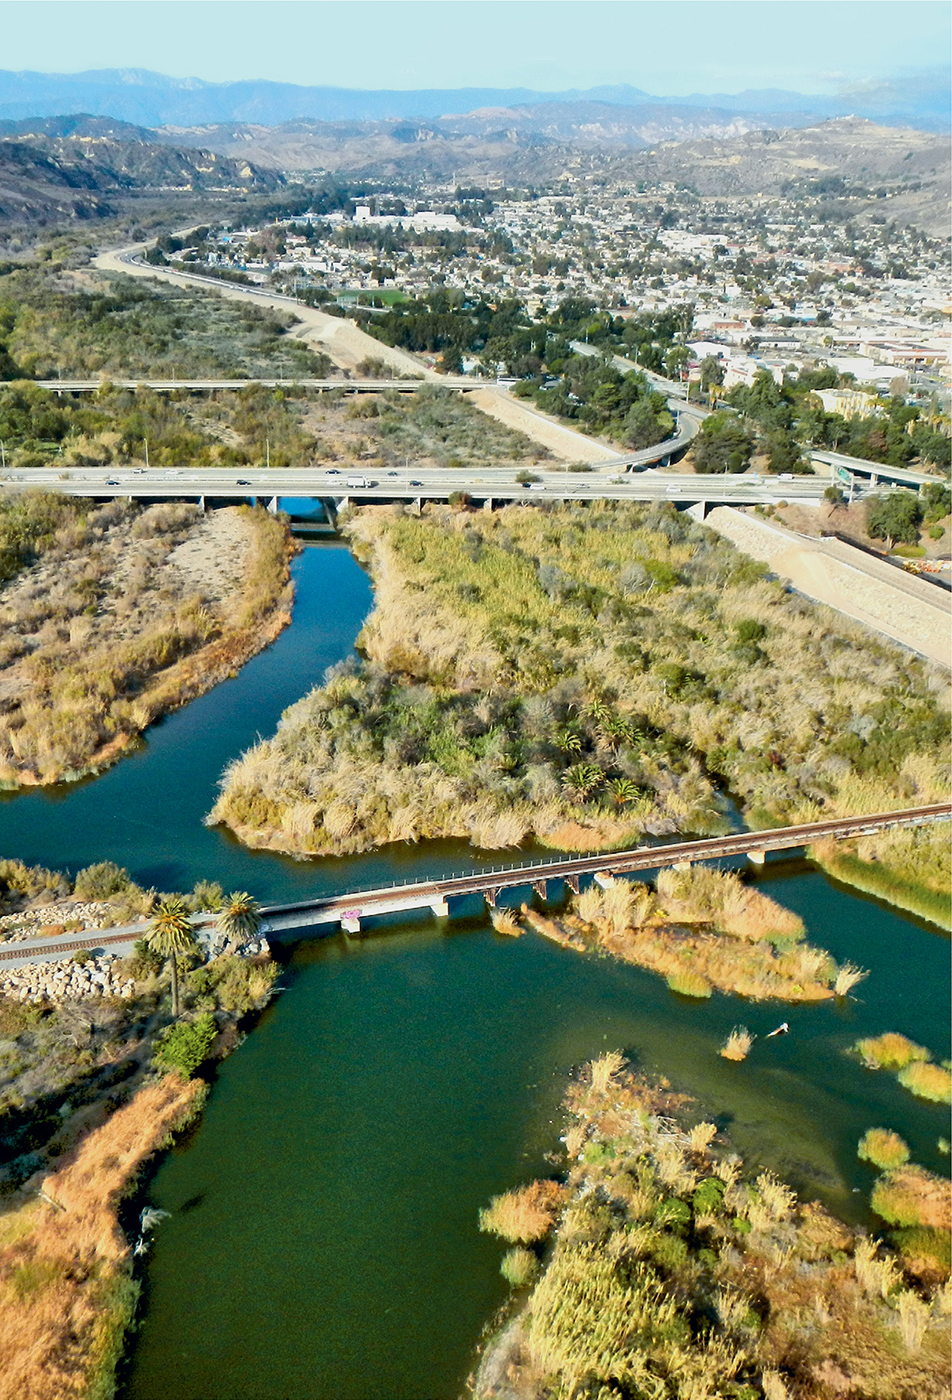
[0,64,949,130]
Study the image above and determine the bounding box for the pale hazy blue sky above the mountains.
[0,0,952,94]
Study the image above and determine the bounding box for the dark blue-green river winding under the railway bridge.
[0,543,949,1400]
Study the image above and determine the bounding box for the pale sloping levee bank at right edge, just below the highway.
[704,505,952,668]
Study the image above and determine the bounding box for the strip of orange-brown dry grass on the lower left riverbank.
[0,1075,203,1400]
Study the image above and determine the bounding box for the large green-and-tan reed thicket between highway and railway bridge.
[210,501,951,921]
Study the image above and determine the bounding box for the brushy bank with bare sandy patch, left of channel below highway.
[0,491,294,788]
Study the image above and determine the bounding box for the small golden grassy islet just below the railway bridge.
[512,865,865,1008]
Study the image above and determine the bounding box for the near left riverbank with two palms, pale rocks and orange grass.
[0,860,279,1400]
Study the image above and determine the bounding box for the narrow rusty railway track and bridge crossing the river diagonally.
[0,802,952,966]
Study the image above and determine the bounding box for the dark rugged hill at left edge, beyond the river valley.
[0,115,284,223]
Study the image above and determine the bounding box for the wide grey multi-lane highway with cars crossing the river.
[0,462,829,505]
